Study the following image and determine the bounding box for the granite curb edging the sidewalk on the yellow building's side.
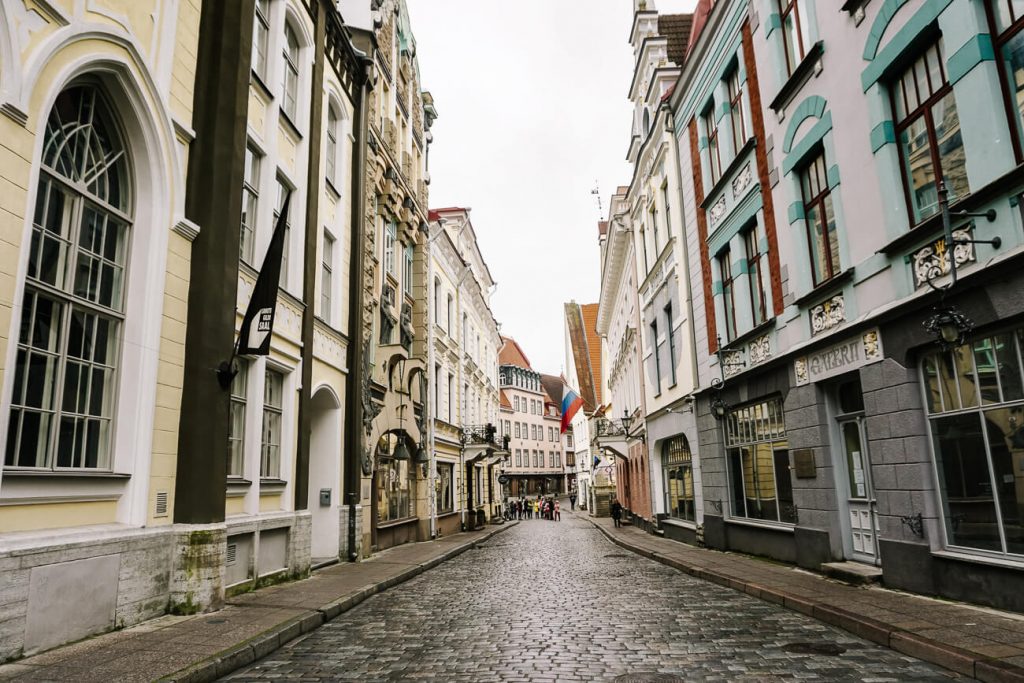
[159,521,518,683]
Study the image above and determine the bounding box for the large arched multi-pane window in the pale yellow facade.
[4,84,132,469]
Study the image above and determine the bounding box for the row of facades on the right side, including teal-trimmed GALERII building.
[566,0,1024,610]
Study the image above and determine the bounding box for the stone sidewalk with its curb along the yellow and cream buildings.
[0,522,515,683]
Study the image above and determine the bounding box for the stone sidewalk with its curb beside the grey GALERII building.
[588,517,1024,683]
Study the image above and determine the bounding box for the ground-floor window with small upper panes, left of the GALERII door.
[725,398,797,523]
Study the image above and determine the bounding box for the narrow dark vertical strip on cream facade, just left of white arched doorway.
[295,2,327,510]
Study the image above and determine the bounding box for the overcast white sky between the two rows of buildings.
[408,0,695,374]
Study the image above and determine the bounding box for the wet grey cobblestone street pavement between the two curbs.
[220,514,967,683]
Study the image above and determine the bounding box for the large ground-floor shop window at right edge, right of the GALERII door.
[923,330,1024,555]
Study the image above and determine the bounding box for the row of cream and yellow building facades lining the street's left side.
[0,0,577,660]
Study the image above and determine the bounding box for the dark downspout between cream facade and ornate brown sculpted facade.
[345,47,374,562]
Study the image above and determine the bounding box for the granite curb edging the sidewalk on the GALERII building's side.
[588,519,1024,683]
